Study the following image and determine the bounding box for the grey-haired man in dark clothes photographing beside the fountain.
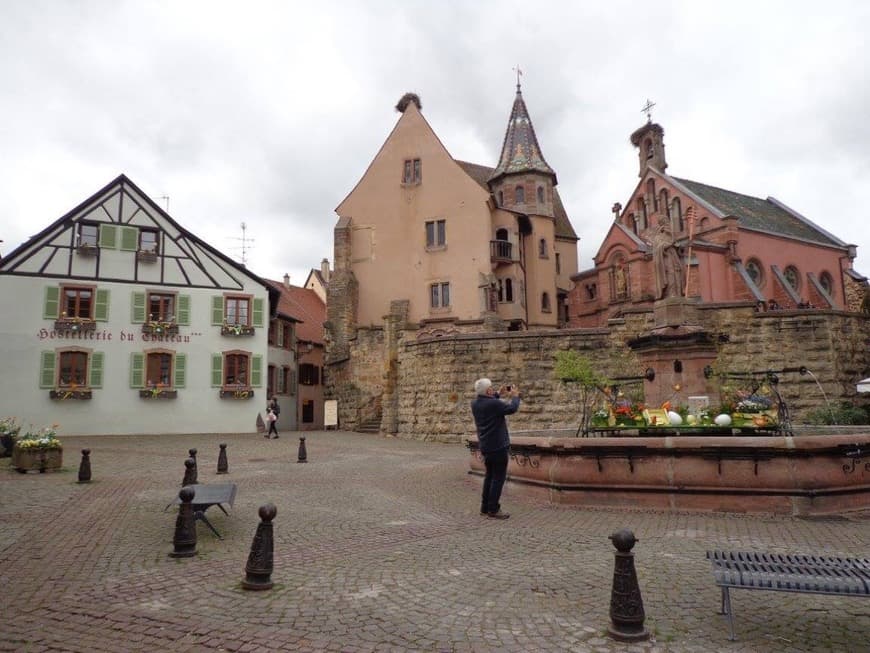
[471,379,520,519]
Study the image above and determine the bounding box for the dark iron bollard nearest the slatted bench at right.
[607,528,649,642]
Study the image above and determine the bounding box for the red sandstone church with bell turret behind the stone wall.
[568,120,866,327]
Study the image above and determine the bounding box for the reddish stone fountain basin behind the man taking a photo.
[468,433,870,516]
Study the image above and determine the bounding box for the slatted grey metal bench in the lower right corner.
[707,551,870,641]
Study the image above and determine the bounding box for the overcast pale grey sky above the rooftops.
[0,0,870,285]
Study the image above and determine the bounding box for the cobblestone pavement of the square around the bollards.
[0,432,870,652]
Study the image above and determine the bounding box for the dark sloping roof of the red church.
[663,175,846,247]
